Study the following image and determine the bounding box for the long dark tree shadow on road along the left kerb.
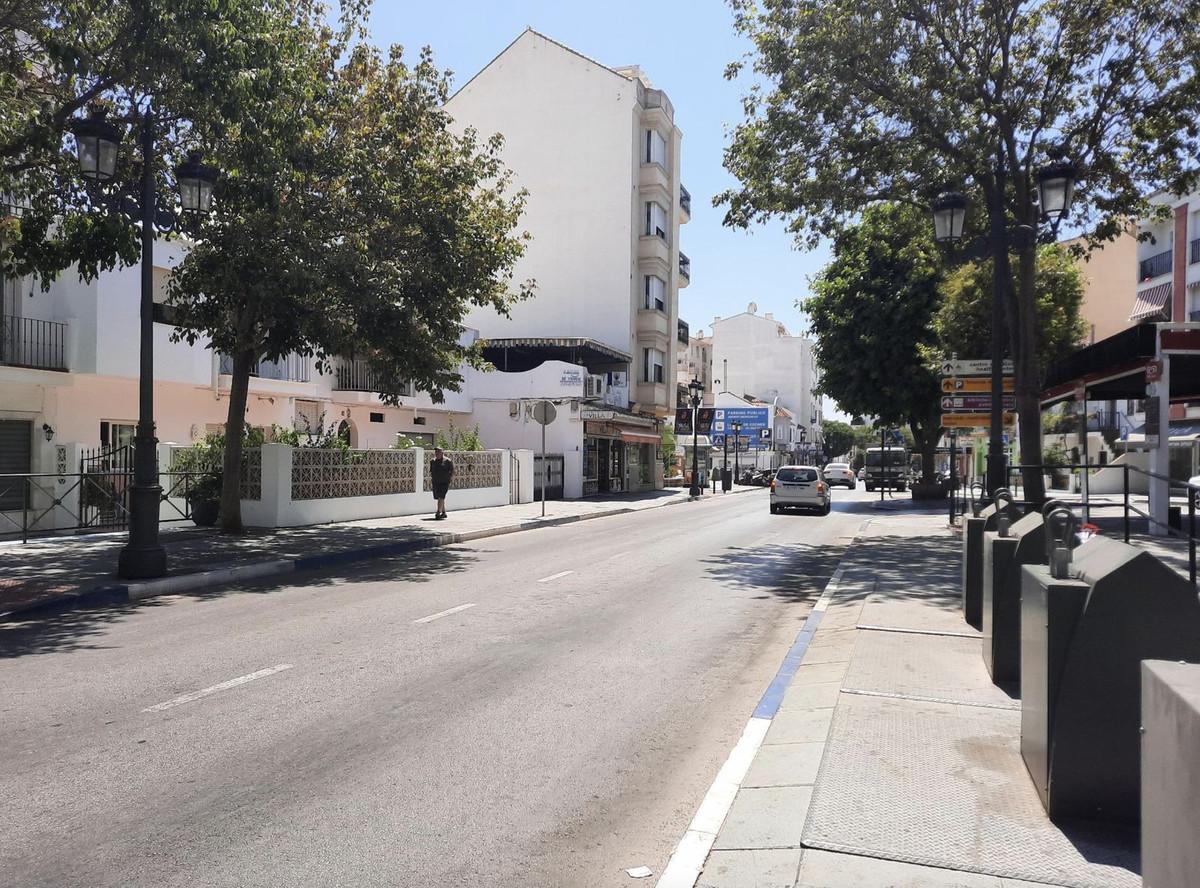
[0,546,481,660]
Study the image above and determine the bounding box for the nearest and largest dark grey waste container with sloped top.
[1020,536,1200,822]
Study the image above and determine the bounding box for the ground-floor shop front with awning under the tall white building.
[583,410,662,497]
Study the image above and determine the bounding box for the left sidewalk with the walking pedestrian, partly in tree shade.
[0,485,764,617]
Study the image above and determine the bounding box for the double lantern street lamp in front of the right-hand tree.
[932,160,1078,492]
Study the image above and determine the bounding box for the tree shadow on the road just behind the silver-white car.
[703,544,846,601]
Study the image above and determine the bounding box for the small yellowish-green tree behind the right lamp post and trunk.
[934,244,1085,373]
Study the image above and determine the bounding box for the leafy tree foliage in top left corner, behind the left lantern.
[0,0,290,286]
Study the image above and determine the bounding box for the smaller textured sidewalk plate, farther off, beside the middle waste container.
[842,630,1021,709]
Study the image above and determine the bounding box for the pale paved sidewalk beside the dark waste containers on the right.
[691,514,1141,888]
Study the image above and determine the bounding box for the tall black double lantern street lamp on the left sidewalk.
[71,108,217,580]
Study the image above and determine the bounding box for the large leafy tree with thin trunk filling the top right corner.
[718,0,1200,499]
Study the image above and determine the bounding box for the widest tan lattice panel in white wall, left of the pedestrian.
[292,448,416,499]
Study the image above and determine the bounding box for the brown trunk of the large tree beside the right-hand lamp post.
[1013,242,1046,506]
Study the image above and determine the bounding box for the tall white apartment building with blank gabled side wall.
[446,30,690,493]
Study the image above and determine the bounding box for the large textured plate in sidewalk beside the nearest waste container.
[803,695,1141,888]
